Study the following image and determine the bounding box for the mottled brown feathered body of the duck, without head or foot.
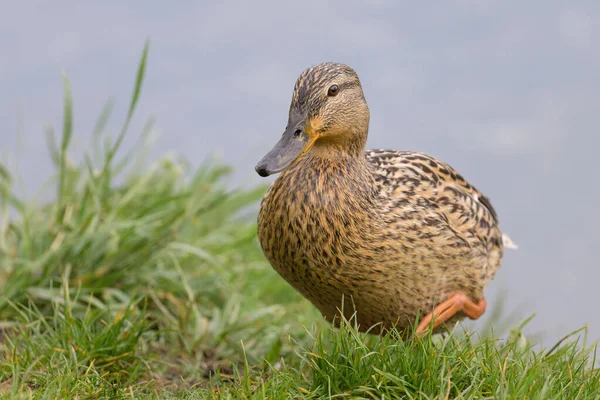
[259,150,502,331]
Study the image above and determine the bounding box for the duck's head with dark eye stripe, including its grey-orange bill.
[255,63,369,176]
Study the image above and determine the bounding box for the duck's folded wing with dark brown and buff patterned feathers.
[365,150,503,251]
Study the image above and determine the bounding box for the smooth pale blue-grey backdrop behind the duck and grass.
[0,0,600,344]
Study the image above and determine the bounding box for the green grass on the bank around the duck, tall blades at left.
[0,42,600,399]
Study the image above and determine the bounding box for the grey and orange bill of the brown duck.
[254,125,316,177]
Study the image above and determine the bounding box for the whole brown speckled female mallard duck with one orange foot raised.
[256,63,509,333]
